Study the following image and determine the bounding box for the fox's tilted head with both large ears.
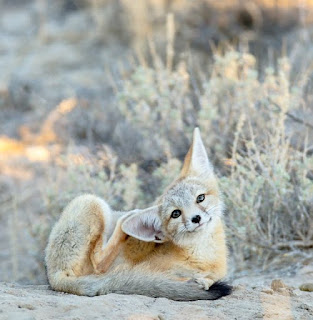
[122,128,223,245]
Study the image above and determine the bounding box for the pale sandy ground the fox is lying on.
[0,270,313,320]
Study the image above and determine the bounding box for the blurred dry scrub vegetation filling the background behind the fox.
[0,0,313,283]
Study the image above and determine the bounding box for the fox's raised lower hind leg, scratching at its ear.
[92,214,129,273]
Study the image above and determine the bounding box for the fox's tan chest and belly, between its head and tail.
[118,216,227,282]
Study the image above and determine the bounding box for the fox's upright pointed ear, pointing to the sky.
[180,128,213,177]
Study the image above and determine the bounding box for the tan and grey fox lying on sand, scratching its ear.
[45,128,231,300]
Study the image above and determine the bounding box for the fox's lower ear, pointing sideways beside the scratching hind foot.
[122,206,165,243]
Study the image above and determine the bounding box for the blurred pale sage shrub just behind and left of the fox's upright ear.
[117,49,194,158]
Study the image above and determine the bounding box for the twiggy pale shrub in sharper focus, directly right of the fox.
[221,112,313,268]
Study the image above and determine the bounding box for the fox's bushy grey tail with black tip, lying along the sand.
[50,270,232,301]
